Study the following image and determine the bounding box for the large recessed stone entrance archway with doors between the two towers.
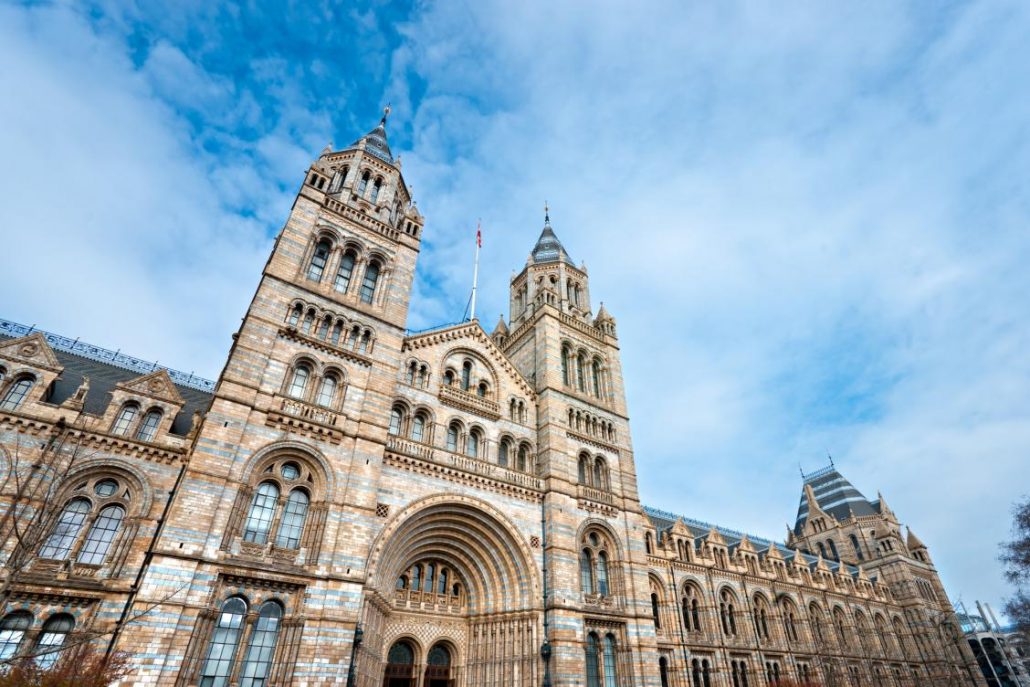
[355,495,543,687]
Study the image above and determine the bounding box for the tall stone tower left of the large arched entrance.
[126,109,422,685]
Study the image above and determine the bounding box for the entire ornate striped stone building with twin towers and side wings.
[0,117,981,687]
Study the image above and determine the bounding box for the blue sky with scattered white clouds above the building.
[0,0,1030,622]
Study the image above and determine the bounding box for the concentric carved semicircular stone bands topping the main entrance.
[368,494,541,613]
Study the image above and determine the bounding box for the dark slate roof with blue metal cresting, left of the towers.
[0,320,214,436]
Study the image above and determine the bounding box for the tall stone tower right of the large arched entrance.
[493,211,657,684]
